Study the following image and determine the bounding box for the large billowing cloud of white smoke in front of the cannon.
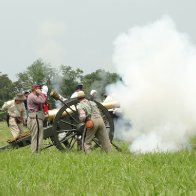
[108,16,196,153]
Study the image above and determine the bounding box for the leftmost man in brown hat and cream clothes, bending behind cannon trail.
[2,94,26,140]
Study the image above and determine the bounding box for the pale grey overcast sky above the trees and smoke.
[0,0,196,80]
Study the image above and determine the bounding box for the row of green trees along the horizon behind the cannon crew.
[0,59,120,107]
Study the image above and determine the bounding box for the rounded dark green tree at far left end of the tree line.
[0,72,16,106]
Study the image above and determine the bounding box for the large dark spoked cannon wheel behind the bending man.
[51,99,114,150]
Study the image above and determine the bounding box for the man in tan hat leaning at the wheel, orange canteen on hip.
[77,91,111,153]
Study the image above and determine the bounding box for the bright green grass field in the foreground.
[0,123,196,196]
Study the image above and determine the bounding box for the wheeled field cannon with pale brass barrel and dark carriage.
[0,91,120,150]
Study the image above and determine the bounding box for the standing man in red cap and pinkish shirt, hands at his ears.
[27,85,46,153]
